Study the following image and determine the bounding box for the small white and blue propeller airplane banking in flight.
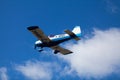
[27,26,81,55]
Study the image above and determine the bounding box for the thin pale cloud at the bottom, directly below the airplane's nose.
[16,61,52,80]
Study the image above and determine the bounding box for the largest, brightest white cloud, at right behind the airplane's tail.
[62,28,120,78]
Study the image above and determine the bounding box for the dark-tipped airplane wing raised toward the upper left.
[27,26,50,43]
